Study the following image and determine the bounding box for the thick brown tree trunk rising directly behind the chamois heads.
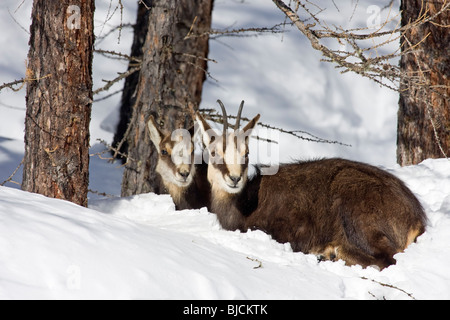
[118,0,213,196]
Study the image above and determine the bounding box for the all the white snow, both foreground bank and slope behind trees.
[0,0,450,299]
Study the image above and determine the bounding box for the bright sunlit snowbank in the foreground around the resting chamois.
[0,159,450,299]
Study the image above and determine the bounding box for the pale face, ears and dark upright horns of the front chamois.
[195,100,260,193]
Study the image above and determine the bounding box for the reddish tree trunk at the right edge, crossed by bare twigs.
[397,0,450,165]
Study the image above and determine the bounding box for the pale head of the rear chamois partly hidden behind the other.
[147,116,195,187]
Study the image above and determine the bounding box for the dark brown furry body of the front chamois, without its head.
[239,159,426,268]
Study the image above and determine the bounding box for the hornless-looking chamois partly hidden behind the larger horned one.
[147,116,211,210]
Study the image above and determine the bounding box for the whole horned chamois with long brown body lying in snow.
[196,101,426,269]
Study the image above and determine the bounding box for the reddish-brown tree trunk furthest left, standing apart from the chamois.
[22,0,95,206]
